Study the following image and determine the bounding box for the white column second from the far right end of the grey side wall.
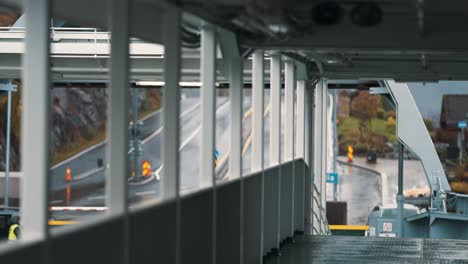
[284,60,296,161]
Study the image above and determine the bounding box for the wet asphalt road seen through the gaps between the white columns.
[51,88,251,219]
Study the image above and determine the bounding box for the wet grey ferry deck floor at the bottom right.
[264,236,468,264]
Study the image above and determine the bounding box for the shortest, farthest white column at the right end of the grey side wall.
[296,80,306,160]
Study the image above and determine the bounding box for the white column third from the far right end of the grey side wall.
[270,54,281,166]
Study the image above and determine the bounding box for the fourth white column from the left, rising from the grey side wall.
[200,24,216,187]
